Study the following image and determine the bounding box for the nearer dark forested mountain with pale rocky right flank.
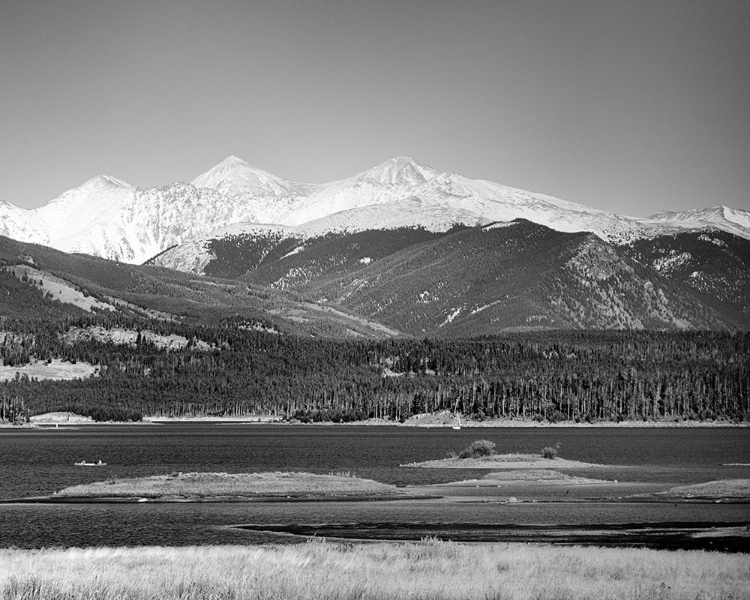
[288,220,737,337]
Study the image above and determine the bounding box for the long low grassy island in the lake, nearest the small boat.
[55,472,399,500]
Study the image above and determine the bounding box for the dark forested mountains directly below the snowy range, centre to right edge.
[157,219,750,337]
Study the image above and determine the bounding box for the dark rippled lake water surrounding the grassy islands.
[0,424,750,547]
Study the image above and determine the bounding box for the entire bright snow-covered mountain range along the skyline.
[0,156,750,270]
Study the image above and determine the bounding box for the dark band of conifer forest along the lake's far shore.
[0,315,750,421]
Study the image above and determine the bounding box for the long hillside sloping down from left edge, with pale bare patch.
[0,236,397,337]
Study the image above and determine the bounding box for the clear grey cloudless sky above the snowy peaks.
[0,0,750,216]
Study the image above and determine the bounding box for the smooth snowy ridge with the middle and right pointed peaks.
[193,156,750,243]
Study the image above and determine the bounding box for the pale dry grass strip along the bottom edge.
[0,540,750,600]
